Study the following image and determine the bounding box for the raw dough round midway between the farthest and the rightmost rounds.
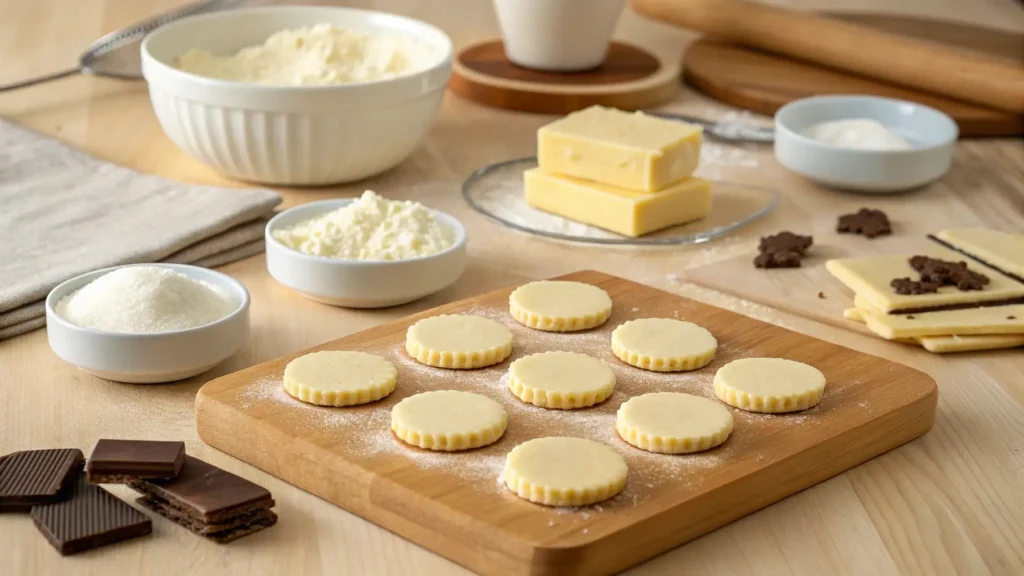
[611,318,718,372]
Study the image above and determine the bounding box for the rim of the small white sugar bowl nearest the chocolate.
[45,262,251,339]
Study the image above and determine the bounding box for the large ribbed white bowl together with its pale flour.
[141,6,453,186]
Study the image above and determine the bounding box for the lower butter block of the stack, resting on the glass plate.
[523,168,711,237]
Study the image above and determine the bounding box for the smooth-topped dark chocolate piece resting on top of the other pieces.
[85,440,185,484]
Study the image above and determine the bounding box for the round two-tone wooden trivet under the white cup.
[450,40,679,114]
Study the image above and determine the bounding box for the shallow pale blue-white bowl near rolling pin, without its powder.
[775,96,958,193]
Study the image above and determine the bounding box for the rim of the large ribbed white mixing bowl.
[139,5,455,93]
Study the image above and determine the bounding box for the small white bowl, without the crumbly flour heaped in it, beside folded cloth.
[264,198,466,308]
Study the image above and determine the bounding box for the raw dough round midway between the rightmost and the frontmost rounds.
[615,392,732,454]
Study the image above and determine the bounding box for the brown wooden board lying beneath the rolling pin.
[683,14,1024,136]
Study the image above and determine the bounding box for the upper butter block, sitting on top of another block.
[537,106,701,192]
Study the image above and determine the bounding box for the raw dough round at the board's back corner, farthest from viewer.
[509,280,611,332]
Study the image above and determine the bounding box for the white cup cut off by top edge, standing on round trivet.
[495,0,626,72]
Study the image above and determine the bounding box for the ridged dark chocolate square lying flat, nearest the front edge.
[32,474,153,556]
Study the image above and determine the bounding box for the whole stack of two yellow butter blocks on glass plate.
[523,107,711,237]
